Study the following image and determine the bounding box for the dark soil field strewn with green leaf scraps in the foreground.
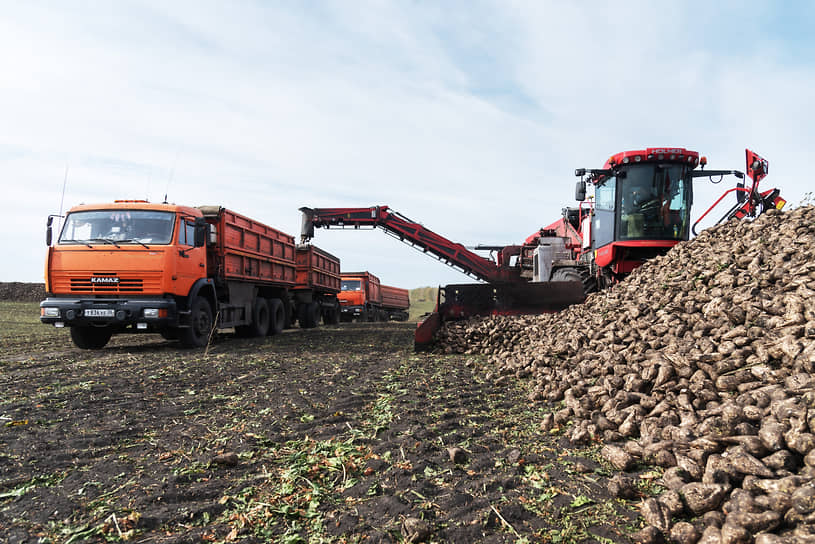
[0,292,644,543]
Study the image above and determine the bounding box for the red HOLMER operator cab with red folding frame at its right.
[575,144,783,288]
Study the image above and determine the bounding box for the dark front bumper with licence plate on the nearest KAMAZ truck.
[40,297,178,330]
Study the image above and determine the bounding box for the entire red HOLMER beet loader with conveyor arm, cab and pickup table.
[300,148,785,349]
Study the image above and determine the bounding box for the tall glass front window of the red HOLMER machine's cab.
[617,164,690,240]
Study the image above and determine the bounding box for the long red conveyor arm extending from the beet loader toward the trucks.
[300,206,517,283]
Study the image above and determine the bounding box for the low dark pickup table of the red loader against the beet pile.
[414,281,586,351]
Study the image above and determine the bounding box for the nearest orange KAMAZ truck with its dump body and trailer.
[40,200,340,349]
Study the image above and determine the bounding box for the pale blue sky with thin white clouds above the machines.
[0,0,815,287]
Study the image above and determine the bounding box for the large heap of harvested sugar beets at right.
[438,206,815,544]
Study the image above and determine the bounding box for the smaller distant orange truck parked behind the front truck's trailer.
[338,272,410,321]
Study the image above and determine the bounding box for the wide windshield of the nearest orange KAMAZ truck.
[59,210,175,245]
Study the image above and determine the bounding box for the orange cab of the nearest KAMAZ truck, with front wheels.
[40,201,210,348]
